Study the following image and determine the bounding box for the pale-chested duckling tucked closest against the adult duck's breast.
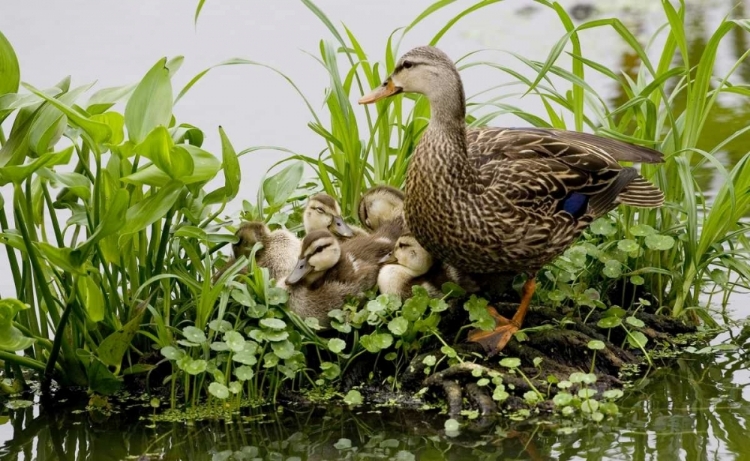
[378,234,479,299]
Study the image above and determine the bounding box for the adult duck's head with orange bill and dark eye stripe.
[359,46,463,105]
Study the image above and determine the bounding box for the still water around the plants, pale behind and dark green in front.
[0,0,750,461]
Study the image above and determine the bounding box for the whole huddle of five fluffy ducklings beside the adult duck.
[232,186,470,328]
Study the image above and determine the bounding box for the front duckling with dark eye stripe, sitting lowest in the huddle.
[284,230,379,327]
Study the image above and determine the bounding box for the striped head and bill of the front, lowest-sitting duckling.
[285,229,341,285]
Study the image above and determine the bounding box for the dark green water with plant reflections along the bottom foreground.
[0,327,750,461]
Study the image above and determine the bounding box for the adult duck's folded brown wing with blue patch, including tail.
[467,128,664,217]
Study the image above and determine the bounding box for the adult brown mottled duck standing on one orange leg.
[359,46,664,355]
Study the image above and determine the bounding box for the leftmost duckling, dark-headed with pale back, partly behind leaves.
[230,221,302,281]
